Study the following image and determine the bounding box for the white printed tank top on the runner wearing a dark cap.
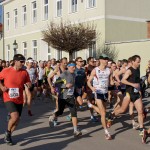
[93,67,110,94]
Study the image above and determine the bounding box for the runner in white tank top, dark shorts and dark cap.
[88,54,114,140]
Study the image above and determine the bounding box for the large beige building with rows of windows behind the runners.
[2,0,150,73]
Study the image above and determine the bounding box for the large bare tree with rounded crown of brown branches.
[42,21,97,60]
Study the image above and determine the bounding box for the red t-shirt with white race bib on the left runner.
[0,67,30,104]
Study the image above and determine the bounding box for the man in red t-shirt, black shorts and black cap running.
[0,54,31,145]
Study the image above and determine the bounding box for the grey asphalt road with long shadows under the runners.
[0,98,150,150]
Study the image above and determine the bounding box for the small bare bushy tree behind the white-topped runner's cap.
[97,44,119,61]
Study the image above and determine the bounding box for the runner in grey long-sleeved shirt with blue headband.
[50,61,82,137]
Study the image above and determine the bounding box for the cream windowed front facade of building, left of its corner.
[2,0,104,60]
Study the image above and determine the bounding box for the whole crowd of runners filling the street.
[0,54,150,145]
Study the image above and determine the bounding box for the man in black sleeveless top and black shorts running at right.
[109,55,145,142]
